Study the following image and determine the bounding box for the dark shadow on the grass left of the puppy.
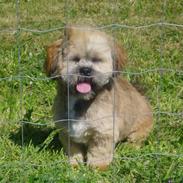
[10,124,62,151]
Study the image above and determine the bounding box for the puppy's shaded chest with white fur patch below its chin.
[69,97,92,143]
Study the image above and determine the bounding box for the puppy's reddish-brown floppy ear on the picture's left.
[44,39,62,76]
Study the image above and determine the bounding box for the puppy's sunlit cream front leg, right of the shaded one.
[87,136,113,170]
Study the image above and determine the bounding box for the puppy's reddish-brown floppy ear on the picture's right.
[114,43,127,71]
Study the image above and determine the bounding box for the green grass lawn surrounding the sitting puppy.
[0,0,183,183]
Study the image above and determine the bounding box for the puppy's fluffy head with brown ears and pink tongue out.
[45,27,126,100]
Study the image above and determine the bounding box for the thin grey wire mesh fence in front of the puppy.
[0,0,183,171]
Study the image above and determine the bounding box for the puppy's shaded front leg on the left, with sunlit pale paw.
[60,134,84,167]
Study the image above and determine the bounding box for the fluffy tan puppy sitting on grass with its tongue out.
[45,26,153,170]
